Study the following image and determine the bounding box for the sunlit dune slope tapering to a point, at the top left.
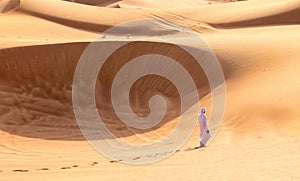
[19,0,149,32]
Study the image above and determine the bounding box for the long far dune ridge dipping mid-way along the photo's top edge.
[19,0,300,32]
